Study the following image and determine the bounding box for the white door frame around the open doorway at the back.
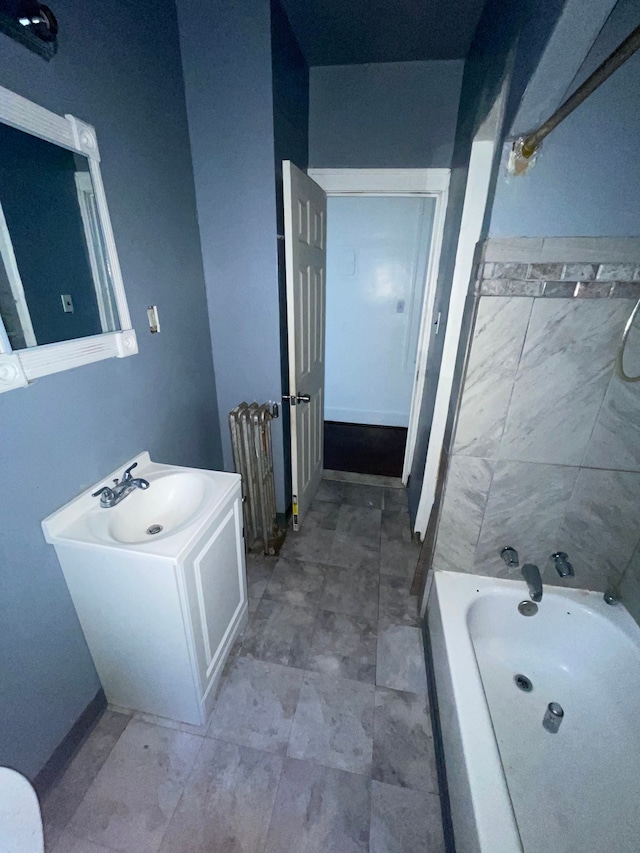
[307,168,451,486]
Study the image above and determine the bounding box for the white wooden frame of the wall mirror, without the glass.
[0,86,138,392]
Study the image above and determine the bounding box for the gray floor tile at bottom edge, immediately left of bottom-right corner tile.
[264,759,371,853]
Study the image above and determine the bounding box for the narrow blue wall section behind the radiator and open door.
[177,0,285,511]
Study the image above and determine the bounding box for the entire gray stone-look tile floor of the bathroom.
[38,480,444,853]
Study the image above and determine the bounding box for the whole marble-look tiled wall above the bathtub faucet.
[433,233,640,592]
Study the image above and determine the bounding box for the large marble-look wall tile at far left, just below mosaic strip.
[454,297,534,458]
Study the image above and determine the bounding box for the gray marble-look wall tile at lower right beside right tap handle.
[553,468,640,590]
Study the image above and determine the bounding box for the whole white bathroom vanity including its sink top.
[43,454,247,725]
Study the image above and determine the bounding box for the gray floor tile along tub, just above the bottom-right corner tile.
[372,687,438,793]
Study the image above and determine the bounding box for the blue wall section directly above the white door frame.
[309,60,464,169]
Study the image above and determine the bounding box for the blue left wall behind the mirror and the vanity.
[0,0,221,777]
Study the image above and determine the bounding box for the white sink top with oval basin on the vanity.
[42,453,238,557]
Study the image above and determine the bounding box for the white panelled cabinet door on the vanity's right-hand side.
[184,497,247,696]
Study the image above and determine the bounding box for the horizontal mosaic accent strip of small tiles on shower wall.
[475,258,640,299]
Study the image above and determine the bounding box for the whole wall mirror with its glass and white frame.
[0,81,138,392]
